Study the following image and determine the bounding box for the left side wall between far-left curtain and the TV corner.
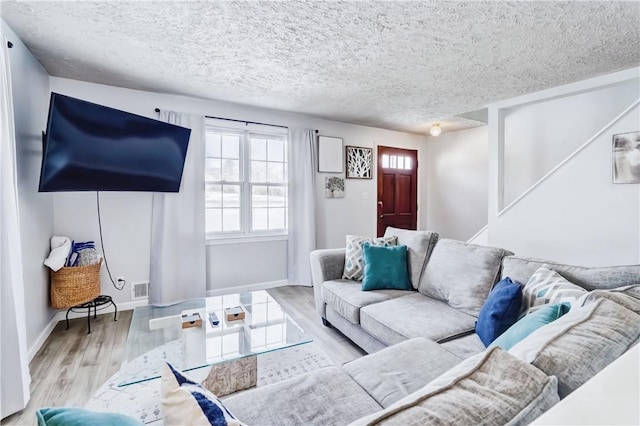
[2,21,55,356]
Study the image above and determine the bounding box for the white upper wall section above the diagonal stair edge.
[504,79,640,205]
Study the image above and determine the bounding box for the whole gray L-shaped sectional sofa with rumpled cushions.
[224,228,640,425]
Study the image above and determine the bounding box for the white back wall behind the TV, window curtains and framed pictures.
[50,77,425,302]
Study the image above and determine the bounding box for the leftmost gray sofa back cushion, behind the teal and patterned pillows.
[384,226,438,289]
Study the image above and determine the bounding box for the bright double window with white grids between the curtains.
[205,127,288,238]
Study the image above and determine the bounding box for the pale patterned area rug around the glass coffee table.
[86,342,334,426]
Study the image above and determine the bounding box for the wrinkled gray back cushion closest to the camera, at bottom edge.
[352,348,558,425]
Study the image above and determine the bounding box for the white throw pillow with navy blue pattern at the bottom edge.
[160,363,243,426]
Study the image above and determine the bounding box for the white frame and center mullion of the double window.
[203,124,289,245]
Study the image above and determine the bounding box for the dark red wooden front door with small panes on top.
[378,146,418,236]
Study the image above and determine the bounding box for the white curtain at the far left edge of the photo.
[0,35,31,418]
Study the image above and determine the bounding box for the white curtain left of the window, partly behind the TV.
[149,111,207,305]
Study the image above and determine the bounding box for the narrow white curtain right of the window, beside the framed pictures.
[287,129,316,286]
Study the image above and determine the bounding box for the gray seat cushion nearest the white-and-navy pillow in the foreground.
[224,366,382,426]
